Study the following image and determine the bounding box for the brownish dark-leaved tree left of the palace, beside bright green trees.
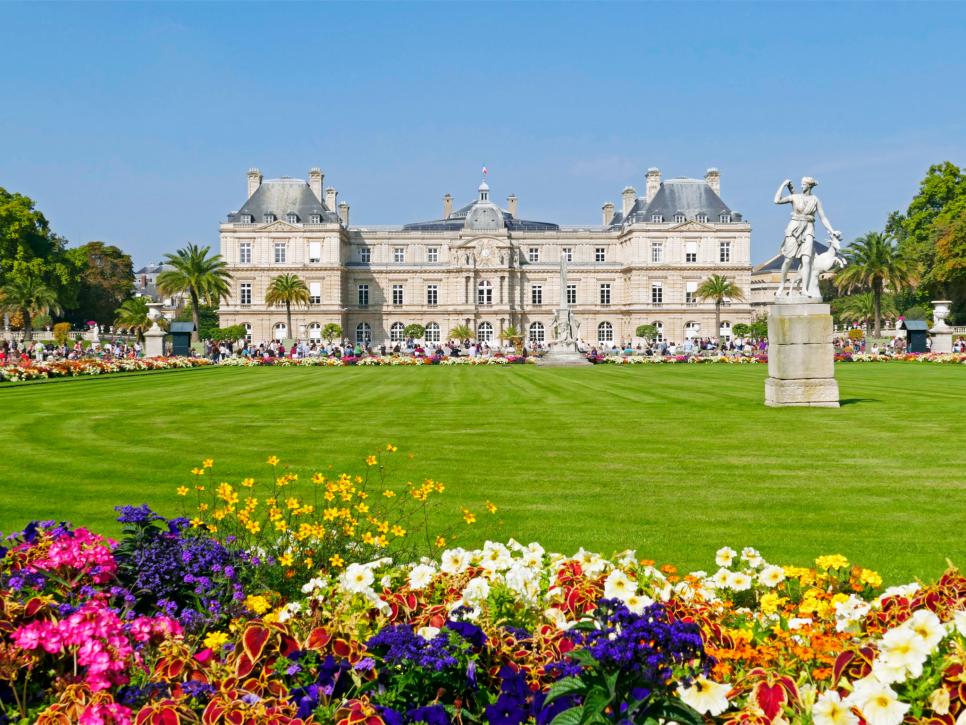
[68,242,134,324]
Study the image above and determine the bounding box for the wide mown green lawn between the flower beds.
[0,363,966,581]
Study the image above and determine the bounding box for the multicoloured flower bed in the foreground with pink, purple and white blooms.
[0,476,966,725]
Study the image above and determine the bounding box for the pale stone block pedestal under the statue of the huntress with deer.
[765,298,839,408]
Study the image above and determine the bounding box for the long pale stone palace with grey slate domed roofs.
[219,169,752,345]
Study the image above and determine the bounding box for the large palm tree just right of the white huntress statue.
[835,232,917,337]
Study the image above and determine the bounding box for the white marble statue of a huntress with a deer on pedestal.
[775,176,842,300]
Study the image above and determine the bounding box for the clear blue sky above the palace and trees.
[0,2,966,264]
